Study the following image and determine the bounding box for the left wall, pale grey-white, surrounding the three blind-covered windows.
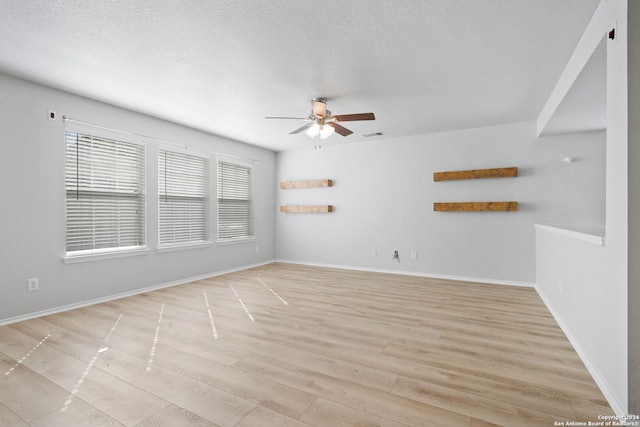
[0,74,275,323]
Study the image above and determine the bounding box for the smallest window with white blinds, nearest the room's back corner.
[218,160,253,242]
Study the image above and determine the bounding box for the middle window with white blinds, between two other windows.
[158,150,209,247]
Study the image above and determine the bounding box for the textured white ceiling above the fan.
[0,0,598,151]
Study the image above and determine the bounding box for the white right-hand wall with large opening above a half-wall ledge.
[537,0,637,415]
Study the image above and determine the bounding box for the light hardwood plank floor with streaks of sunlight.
[0,263,613,427]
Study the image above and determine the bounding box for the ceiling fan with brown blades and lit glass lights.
[265,98,376,139]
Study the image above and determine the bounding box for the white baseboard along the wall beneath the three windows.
[0,260,275,326]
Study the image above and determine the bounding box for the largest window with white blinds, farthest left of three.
[65,130,145,255]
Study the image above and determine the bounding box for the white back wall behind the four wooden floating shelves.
[276,122,605,284]
